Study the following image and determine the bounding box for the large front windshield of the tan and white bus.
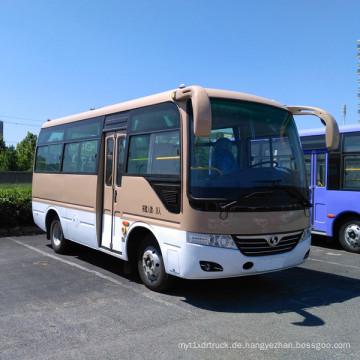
[189,99,308,210]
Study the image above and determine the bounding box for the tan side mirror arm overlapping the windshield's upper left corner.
[171,86,212,137]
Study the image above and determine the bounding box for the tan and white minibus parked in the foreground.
[33,86,338,291]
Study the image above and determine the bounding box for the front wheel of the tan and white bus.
[138,235,174,292]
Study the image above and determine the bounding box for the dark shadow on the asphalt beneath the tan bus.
[51,240,360,327]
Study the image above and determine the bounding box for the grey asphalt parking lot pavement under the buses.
[0,234,360,360]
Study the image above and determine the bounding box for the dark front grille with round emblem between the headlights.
[233,231,302,256]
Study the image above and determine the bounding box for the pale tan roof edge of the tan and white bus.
[42,89,287,128]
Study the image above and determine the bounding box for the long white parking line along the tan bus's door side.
[7,237,192,313]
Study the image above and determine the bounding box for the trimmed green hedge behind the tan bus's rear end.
[0,188,34,228]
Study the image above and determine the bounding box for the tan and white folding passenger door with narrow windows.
[101,131,126,254]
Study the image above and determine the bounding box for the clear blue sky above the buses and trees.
[0,0,360,146]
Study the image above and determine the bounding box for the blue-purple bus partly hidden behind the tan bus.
[299,125,360,253]
